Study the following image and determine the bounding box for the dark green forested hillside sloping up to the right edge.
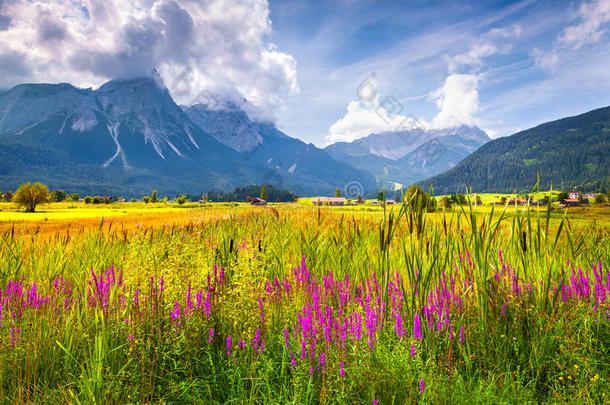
[420,107,610,194]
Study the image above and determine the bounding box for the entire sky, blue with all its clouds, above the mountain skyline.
[0,0,610,146]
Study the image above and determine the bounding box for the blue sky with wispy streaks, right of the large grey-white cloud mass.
[270,0,610,145]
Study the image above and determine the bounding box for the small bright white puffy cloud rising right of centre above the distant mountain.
[431,74,479,128]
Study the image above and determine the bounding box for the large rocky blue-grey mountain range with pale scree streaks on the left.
[0,74,374,196]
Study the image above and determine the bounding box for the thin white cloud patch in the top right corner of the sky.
[559,0,610,49]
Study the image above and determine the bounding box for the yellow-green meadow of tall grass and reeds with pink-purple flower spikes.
[0,201,610,404]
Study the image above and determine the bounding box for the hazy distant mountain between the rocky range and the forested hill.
[325,126,489,185]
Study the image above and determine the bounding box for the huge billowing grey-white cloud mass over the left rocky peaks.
[0,0,299,118]
